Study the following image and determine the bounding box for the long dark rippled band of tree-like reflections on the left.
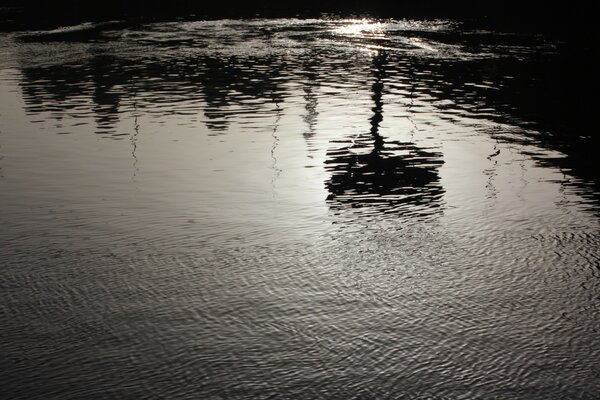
[21,45,285,138]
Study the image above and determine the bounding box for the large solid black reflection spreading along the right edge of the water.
[382,31,600,209]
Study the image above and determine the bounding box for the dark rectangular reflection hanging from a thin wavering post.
[326,51,444,219]
